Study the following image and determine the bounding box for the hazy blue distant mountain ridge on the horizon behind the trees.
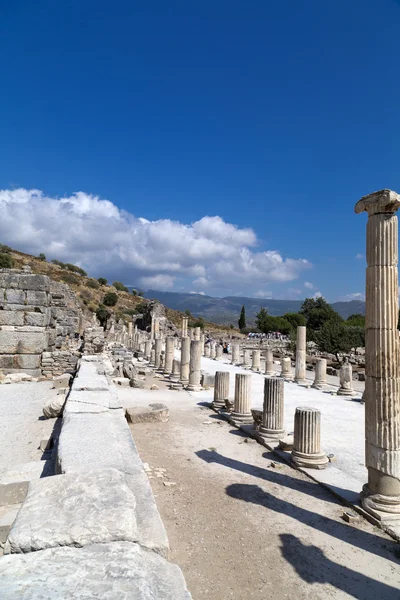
[144,290,365,327]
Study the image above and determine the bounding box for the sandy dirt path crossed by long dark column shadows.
[132,392,400,600]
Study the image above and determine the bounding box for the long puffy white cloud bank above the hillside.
[0,189,311,296]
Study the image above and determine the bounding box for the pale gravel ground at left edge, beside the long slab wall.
[0,381,57,477]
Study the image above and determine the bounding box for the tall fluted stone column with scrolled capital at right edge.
[355,190,400,520]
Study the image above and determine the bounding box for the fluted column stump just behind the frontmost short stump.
[259,377,285,440]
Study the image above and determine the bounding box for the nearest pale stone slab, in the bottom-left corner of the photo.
[0,542,191,600]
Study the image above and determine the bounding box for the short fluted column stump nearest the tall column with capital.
[291,406,329,469]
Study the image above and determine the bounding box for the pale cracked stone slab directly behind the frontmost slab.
[4,469,138,554]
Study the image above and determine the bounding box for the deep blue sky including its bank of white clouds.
[0,0,400,301]
